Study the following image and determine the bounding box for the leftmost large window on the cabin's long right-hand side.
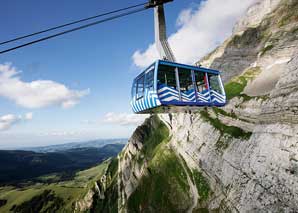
[157,65,177,89]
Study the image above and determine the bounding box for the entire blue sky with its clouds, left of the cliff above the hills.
[0,0,253,148]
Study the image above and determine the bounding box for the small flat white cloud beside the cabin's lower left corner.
[104,112,149,126]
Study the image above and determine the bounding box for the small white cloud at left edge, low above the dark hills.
[0,112,33,131]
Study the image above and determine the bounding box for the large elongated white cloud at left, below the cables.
[0,64,89,108]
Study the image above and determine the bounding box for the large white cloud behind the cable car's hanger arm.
[132,0,257,67]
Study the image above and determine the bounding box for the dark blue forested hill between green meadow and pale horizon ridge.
[0,144,124,185]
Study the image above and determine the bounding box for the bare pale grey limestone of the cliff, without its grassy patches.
[158,0,298,212]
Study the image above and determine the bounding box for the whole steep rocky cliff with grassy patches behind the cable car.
[93,0,298,212]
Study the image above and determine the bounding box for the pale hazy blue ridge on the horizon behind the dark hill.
[22,138,128,153]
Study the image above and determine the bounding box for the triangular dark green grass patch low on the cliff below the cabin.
[128,144,191,212]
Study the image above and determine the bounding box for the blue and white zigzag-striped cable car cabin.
[131,60,226,114]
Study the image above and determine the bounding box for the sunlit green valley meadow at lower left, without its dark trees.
[0,162,109,212]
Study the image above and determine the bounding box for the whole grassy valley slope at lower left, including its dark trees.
[0,161,109,213]
